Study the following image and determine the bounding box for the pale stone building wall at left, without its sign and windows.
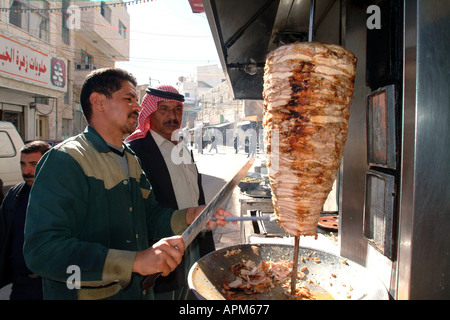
[0,0,130,140]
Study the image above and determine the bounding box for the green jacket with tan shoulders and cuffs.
[24,126,187,299]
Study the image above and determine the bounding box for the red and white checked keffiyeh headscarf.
[125,85,183,142]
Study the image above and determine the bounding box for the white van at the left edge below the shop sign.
[0,121,24,195]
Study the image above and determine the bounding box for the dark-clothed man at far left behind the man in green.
[0,141,51,300]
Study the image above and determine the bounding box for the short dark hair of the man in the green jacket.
[80,68,137,123]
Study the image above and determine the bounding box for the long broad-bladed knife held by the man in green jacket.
[141,158,255,290]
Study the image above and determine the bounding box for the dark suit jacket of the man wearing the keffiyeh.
[129,131,215,292]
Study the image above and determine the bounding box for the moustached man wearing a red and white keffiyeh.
[125,85,215,300]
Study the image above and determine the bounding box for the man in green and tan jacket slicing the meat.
[24,68,230,299]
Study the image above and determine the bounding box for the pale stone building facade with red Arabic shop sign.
[0,0,130,141]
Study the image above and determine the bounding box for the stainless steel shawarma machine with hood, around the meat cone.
[202,0,450,299]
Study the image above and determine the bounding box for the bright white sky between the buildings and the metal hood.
[116,0,220,86]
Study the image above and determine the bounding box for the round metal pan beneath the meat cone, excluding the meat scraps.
[188,244,389,300]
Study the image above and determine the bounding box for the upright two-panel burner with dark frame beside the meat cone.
[363,85,398,260]
